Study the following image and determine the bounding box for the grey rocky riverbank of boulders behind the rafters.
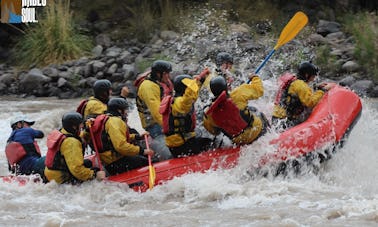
[0,15,378,98]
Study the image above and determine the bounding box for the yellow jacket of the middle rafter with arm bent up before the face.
[165,80,202,147]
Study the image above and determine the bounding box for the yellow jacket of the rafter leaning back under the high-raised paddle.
[203,76,264,144]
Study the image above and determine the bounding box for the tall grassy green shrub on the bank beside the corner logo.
[14,0,92,68]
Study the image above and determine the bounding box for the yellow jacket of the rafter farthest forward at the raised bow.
[272,79,324,119]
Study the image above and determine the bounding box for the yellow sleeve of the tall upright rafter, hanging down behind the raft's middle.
[138,80,163,126]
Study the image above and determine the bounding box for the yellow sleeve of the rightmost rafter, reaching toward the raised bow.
[288,80,324,108]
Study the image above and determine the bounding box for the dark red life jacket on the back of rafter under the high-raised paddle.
[206,91,253,138]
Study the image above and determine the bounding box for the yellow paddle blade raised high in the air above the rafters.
[274,11,308,50]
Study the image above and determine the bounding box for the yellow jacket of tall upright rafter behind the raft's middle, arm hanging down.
[137,79,163,129]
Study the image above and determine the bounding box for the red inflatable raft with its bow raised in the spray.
[108,86,362,192]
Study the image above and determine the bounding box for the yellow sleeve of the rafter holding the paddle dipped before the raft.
[105,117,140,156]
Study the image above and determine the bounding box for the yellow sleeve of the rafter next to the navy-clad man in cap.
[60,137,94,181]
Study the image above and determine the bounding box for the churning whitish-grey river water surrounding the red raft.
[0,93,378,226]
